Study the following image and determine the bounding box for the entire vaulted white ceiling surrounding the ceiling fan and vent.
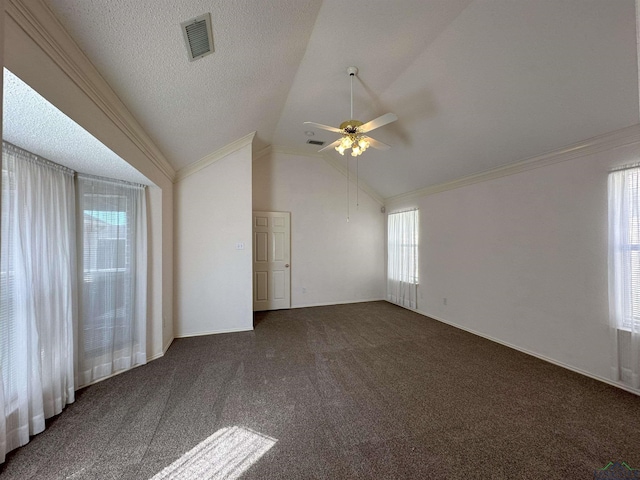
[46,0,638,198]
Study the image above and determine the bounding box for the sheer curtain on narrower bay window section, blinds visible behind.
[77,175,147,386]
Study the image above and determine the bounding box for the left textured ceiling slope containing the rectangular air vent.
[47,0,321,169]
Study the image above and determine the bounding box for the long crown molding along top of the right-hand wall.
[384,124,640,206]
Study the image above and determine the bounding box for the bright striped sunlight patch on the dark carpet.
[151,427,278,480]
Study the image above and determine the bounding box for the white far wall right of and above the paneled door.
[253,150,385,307]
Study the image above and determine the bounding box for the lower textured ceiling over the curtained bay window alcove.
[2,69,151,185]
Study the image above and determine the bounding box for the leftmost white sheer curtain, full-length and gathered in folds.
[0,143,76,461]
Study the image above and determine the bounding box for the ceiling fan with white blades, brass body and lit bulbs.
[304,67,398,157]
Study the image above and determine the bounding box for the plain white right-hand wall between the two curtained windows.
[388,128,640,386]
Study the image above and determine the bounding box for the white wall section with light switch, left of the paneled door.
[175,144,253,337]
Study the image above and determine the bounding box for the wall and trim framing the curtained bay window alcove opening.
[4,2,174,359]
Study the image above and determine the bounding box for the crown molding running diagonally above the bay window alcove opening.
[5,0,175,181]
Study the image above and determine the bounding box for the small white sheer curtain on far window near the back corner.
[387,210,418,309]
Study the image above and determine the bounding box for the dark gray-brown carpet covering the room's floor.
[0,302,640,480]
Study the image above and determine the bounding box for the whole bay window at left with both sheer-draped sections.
[0,142,147,463]
